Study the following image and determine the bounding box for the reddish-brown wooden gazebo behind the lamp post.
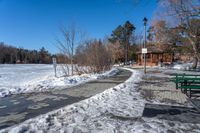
[137,46,173,66]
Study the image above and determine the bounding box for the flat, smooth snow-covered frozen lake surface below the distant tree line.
[0,64,54,87]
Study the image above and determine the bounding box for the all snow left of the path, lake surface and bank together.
[0,64,118,97]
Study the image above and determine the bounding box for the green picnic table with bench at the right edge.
[171,73,200,98]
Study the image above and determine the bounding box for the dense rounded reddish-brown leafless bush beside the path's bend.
[76,40,113,73]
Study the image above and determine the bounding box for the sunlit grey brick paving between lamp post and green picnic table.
[138,69,189,105]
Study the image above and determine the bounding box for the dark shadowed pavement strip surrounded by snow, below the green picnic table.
[143,104,200,124]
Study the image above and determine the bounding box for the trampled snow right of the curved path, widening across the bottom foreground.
[0,69,200,133]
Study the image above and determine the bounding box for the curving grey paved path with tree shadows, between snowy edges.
[0,69,131,129]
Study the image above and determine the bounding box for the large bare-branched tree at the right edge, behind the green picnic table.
[156,0,200,68]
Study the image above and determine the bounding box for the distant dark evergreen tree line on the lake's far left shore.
[0,42,52,64]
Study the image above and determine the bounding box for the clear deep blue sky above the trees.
[0,0,156,53]
